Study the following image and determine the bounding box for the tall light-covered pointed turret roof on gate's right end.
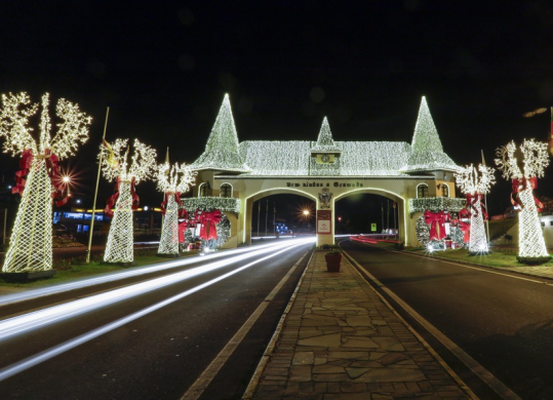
[402,96,458,172]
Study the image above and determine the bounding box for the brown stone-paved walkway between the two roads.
[244,251,470,400]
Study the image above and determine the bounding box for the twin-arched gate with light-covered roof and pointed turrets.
[191,95,458,247]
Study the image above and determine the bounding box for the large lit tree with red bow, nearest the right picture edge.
[495,139,550,264]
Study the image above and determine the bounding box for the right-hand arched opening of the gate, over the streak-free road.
[332,188,409,242]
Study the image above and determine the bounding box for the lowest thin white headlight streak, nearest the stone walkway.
[0,240,312,382]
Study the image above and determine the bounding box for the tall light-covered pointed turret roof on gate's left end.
[191,94,250,172]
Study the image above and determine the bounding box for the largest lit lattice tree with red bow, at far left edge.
[0,92,92,273]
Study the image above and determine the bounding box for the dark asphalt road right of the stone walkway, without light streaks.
[342,242,553,400]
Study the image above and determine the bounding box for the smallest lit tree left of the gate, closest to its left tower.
[156,160,197,255]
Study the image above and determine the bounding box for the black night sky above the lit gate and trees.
[0,0,553,219]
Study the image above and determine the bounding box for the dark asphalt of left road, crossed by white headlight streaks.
[0,239,312,400]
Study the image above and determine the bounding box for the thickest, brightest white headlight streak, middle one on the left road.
[0,241,312,342]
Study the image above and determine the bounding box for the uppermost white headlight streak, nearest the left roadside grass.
[0,243,302,306]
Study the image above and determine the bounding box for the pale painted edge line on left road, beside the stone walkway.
[181,252,308,400]
